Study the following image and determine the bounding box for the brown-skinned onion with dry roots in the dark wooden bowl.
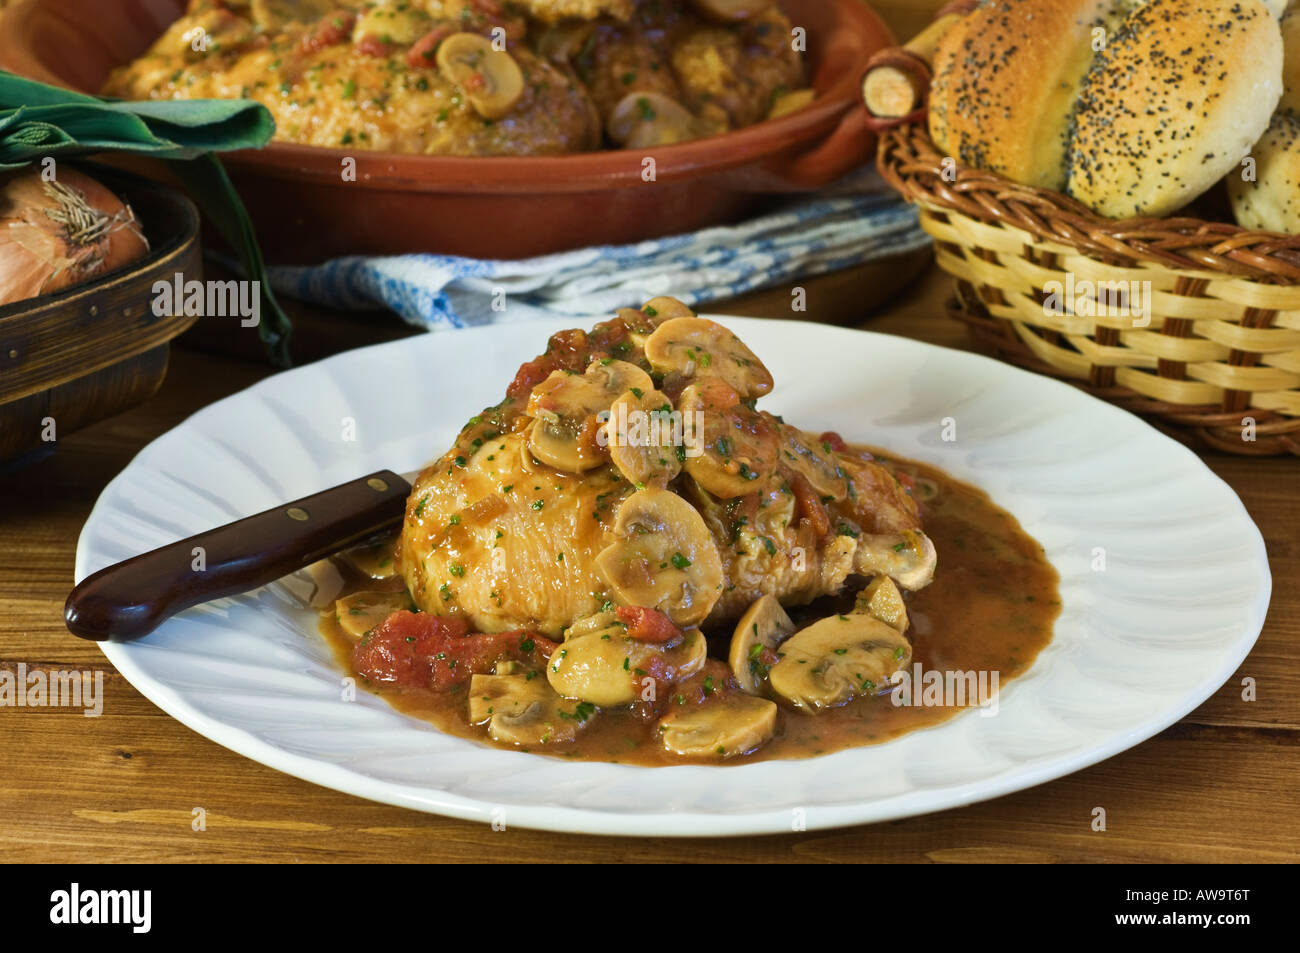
[0,168,150,306]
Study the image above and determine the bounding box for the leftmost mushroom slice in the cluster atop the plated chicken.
[524,360,654,473]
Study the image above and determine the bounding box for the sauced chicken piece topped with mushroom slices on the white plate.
[398,299,935,637]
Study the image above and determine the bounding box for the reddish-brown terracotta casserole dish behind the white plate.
[0,0,893,263]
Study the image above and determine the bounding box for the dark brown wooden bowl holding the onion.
[0,165,203,462]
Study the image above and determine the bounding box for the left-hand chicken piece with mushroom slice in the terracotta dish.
[104,0,602,156]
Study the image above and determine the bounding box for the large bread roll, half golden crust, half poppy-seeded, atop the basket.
[930,0,1284,218]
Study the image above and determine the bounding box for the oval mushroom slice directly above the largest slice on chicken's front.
[605,389,690,489]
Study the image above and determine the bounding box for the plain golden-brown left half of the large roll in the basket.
[930,0,1126,190]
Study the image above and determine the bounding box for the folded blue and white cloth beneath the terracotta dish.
[268,192,930,330]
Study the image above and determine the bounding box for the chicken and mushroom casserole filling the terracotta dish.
[104,0,811,156]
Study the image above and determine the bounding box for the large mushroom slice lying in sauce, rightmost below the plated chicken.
[767,612,911,711]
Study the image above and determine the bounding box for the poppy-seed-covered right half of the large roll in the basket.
[1067,0,1283,218]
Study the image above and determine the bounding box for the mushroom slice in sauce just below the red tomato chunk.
[469,675,595,745]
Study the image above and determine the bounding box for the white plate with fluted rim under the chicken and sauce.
[77,319,1271,836]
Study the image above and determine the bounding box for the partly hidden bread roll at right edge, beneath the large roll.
[1227,109,1300,235]
